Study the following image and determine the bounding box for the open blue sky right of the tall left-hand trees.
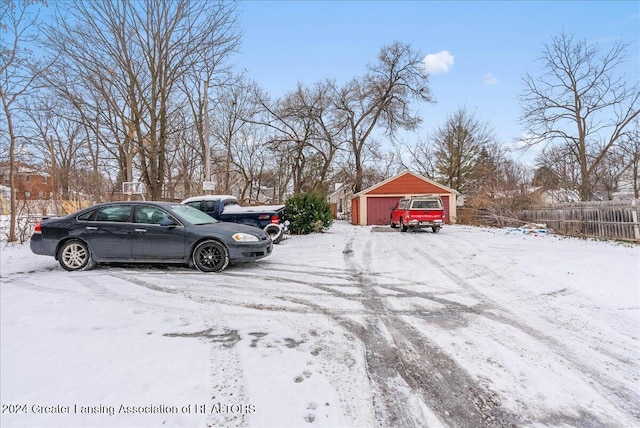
[234,0,640,164]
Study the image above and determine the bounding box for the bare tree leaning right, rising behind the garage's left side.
[337,42,433,192]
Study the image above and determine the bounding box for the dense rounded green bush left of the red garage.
[285,193,333,235]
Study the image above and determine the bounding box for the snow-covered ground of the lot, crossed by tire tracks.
[0,222,640,428]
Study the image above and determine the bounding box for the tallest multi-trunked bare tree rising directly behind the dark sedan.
[40,0,239,199]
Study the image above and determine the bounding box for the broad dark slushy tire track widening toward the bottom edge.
[341,237,522,427]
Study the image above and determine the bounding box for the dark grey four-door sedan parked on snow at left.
[31,202,273,272]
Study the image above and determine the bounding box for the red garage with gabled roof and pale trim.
[351,171,458,226]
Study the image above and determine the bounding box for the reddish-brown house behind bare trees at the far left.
[0,163,53,201]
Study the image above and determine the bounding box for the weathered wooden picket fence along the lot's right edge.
[518,199,640,242]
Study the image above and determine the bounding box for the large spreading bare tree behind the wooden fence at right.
[520,33,640,200]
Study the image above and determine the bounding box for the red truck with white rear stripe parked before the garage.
[390,195,444,233]
